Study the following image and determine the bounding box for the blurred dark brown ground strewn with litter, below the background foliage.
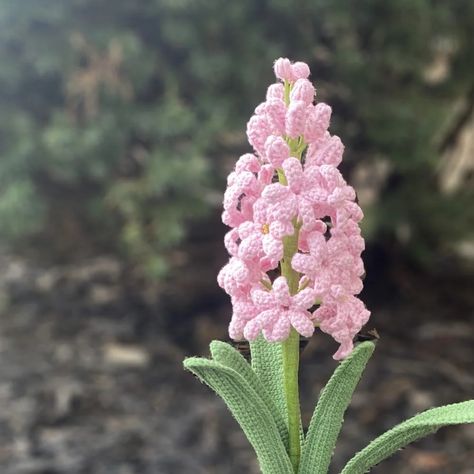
[0,248,474,474]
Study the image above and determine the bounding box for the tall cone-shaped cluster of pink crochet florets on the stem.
[218,58,370,359]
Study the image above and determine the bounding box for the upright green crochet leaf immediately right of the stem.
[298,341,375,474]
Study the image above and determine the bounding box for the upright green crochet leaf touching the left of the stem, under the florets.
[250,336,288,424]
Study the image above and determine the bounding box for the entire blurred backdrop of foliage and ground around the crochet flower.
[0,0,474,474]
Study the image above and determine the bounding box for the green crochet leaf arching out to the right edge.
[341,400,474,474]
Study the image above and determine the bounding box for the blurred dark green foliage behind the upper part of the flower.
[0,0,474,275]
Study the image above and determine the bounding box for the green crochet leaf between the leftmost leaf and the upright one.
[210,341,288,449]
